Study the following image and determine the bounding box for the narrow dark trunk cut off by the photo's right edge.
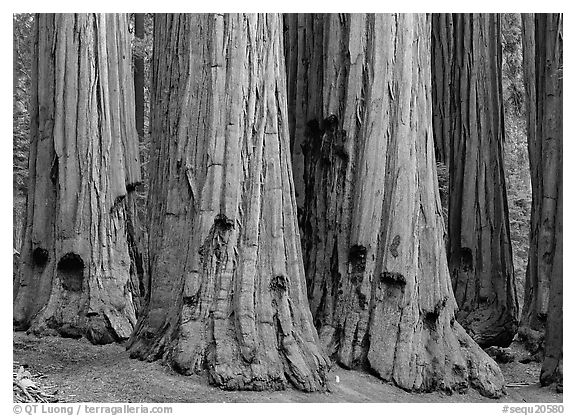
[521,14,563,384]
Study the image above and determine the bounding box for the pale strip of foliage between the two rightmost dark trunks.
[502,13,532,314]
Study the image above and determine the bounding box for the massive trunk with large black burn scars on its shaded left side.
[285,14,503,396]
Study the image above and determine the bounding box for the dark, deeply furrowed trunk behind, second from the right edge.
[432,14,519,346]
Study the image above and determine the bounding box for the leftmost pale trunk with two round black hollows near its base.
[14,14,140,343]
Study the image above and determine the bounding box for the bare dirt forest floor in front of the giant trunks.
[13,332,563,403]
